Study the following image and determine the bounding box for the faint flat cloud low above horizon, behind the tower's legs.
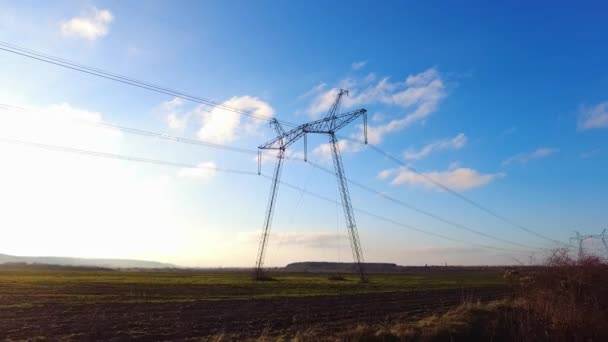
[237,231,348,248]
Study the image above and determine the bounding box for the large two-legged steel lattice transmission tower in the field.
[255,89,367,281]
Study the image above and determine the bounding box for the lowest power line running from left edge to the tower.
[0,138,257,176]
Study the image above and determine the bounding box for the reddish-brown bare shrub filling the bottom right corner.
[510,250,608,341]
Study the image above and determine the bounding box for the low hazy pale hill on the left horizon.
[0,254,175,268]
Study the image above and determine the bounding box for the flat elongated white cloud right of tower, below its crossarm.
[378,167,504,190]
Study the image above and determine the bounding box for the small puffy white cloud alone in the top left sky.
[61,7,114,41]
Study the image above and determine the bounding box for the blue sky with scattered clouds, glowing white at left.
[0,1,608,266]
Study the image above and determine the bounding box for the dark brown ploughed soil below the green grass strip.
[0,287,508,341]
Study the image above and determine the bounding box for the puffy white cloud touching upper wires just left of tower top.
[195,96,273,144]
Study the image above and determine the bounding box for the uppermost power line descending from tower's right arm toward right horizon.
[340,137,567,246]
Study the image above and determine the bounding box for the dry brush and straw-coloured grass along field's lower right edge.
[308,250,608,342]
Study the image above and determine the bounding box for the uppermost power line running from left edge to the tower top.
[0,41,297,127]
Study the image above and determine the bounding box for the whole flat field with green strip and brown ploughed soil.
[0,269,508,340]
